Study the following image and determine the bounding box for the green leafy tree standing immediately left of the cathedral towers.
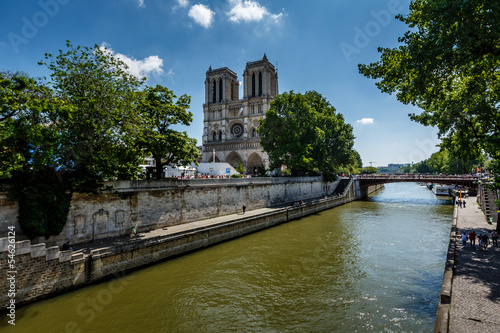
[137,85,199,179]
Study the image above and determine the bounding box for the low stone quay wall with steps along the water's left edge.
[0,181,383,312]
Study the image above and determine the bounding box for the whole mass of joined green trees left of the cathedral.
[0,41,198,238]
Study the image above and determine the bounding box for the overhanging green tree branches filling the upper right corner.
[359,0,500,169]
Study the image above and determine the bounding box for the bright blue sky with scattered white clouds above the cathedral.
[0,0,439,166]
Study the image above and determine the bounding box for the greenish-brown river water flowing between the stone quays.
[0,183,453,333]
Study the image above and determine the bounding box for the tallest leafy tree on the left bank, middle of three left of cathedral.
[39,41,143,192]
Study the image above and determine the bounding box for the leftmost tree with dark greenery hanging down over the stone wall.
[0,72,71,238]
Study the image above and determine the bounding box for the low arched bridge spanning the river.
[358,174,479,191]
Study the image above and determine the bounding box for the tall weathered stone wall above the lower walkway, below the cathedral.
[0,177,338,246]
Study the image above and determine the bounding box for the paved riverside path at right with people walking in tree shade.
[449,197,500,333]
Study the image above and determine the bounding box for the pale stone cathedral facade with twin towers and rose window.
[202,54,278,174]
